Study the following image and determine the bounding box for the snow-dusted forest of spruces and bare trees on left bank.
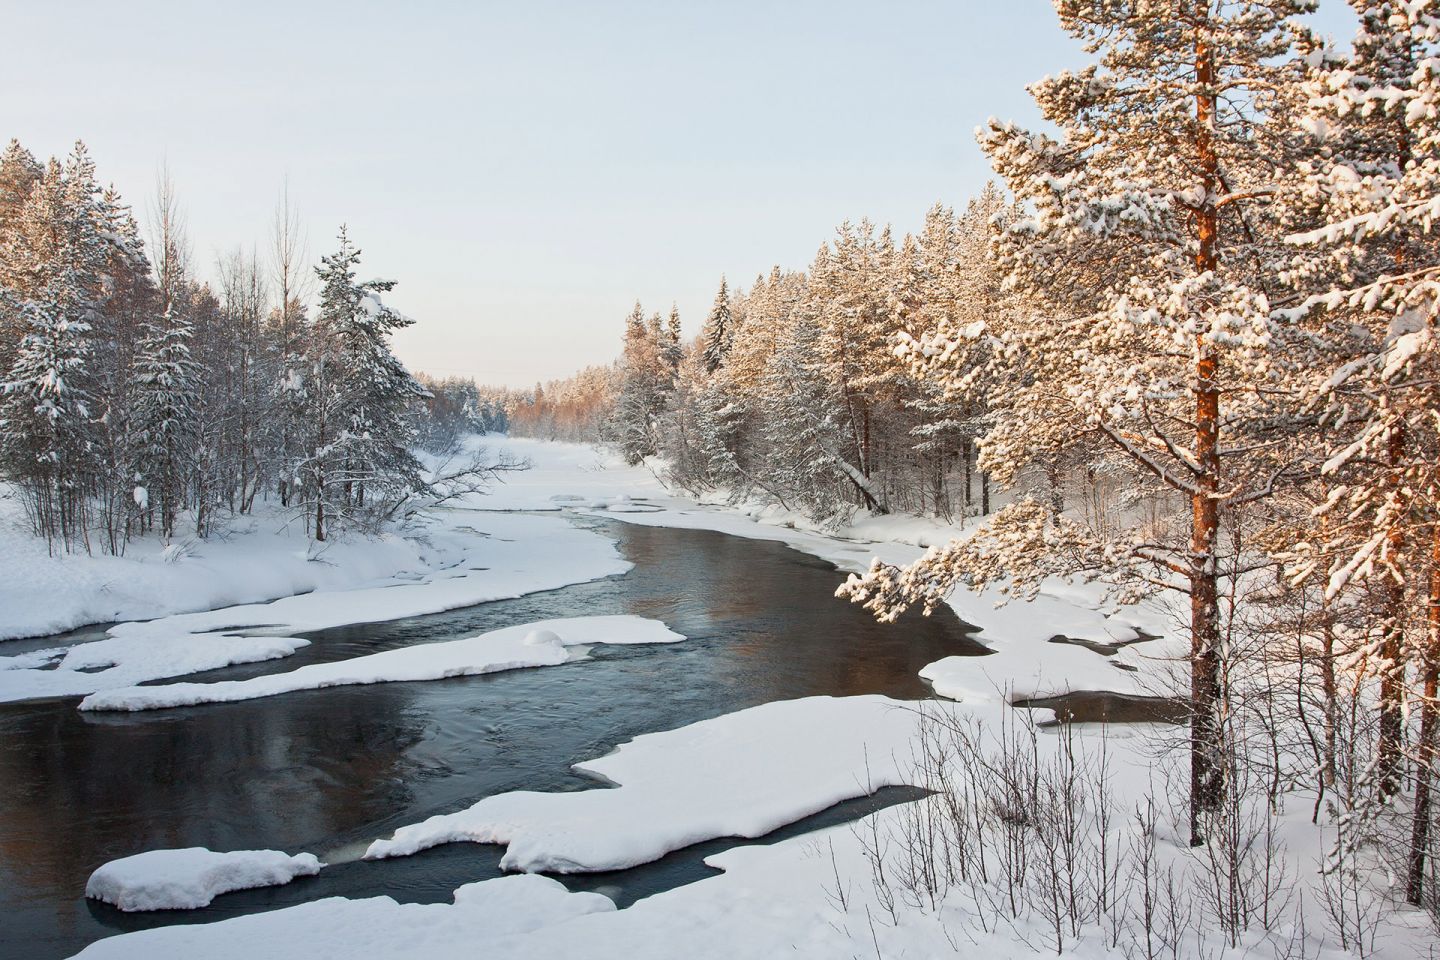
[0,141,504,554]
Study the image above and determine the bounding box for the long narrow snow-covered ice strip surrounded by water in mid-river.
[78,616,685,710]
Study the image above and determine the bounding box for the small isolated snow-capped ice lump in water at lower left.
[85,846,324,913]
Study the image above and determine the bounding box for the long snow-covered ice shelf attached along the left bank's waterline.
[0,512,631,702]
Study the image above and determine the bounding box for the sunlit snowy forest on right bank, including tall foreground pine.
[510,1,1440,910]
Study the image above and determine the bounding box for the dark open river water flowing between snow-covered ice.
[0,524,982,960]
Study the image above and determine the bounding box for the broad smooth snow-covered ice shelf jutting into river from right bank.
[366,695,917,874]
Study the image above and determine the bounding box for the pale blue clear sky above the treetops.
[8,0,1354,387]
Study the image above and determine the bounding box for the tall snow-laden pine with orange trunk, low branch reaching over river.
[848,0,1309,842]
